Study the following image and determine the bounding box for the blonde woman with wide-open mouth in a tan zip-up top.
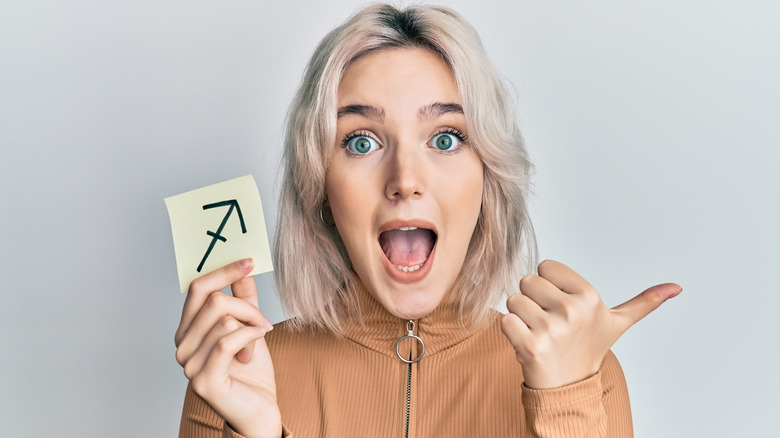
[176,5,680,437]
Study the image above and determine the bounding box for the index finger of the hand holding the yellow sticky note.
[176,259,257,344]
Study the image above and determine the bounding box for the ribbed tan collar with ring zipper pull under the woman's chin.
[344,280,480,362]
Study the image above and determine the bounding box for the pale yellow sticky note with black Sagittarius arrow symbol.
[165,175,273,293]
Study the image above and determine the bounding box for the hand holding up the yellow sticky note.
[175,259,282,438]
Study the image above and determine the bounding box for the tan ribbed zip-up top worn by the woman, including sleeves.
[180,290,633,438]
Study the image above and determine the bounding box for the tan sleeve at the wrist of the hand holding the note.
[179,383,293,438]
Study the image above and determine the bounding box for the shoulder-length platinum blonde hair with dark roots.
[274,4,537,333]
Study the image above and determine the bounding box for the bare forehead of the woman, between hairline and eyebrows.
[338,48,460,108]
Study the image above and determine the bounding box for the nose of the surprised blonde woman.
[385,141,425,201]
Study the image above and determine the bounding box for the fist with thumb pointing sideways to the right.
[501,260,682,389]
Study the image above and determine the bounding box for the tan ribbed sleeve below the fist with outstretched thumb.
[522,351,634,438]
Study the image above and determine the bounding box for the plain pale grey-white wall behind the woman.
[0,0,780,437]
